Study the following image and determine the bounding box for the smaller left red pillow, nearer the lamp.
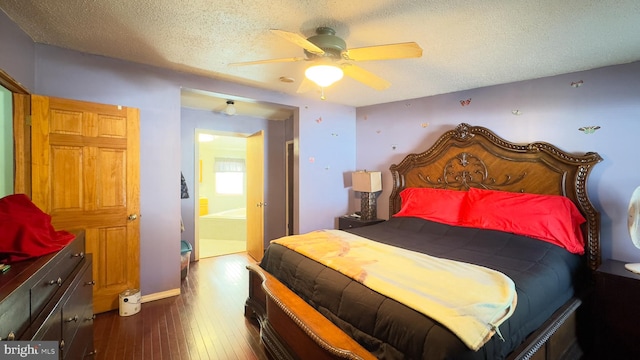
[393,188,467,225]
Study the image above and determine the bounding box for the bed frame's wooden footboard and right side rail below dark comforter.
[245,264,582,360]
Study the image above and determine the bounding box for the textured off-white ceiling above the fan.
[0,0,640,115]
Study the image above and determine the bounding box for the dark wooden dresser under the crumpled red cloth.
[0,231,94,359]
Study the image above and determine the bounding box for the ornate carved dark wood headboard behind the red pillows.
[389,123,602,270]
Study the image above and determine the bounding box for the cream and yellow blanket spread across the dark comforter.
[272,230,516,350]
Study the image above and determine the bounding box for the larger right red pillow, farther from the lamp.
[461,188,586,254]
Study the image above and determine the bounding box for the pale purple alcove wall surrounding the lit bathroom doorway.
[180,108,292,253]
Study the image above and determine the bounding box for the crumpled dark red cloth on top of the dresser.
[0,194,75,263]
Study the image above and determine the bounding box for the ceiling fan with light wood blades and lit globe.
[229,26,422,100]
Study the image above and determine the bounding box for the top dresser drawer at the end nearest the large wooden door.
[30,237,85,319]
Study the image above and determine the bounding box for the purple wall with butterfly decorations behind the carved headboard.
[358,62,640,262]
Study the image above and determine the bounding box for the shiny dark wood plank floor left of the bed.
[94,253,267,360]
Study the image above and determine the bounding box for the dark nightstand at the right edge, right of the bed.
[594,260,640,359]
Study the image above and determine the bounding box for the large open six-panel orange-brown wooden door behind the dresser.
[31,95,140,313]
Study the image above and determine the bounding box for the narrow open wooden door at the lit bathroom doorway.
[247,130,267,261]
